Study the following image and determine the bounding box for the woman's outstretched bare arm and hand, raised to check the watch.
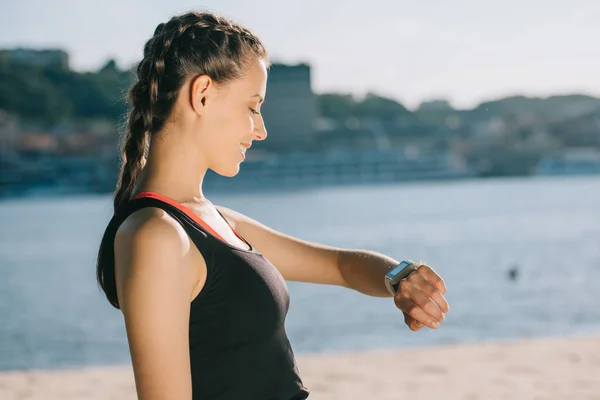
[217,207,449,331]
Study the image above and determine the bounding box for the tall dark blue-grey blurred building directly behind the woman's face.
[257,63,315,151]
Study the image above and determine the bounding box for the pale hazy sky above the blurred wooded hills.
[0,0,600,108]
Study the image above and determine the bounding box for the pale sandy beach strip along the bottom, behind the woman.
[0,337,600,400]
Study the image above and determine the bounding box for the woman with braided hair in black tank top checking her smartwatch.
[97,12,448,400]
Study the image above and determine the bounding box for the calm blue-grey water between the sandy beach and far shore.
[0,177,600,370]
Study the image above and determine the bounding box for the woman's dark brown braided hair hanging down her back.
[96,12,267,308]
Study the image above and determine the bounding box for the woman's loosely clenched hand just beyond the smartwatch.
[394,262,449,331]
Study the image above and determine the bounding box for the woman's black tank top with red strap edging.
[113,192,309,400]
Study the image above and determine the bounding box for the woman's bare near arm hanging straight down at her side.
[115,210,197,400]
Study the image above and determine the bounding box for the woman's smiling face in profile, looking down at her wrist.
[193,59,267,177]
